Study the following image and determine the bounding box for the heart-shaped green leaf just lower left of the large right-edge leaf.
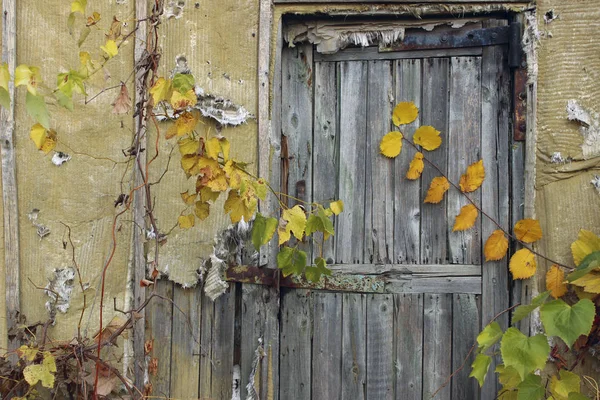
[500,327,550,379]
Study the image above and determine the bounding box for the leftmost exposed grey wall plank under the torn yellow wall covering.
[146,279,173,398]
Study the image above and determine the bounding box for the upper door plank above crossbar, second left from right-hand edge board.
[421,58,450,264]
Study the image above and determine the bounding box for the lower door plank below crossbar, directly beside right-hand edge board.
[452,293,480,400]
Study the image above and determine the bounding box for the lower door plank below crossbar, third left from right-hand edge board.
[393,294,423,400]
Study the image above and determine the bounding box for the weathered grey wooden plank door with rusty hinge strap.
[279,21,518,400]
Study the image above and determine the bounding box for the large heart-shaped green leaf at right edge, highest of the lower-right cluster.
[540,299,596,348]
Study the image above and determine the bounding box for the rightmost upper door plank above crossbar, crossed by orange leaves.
[446,57,482,264]
